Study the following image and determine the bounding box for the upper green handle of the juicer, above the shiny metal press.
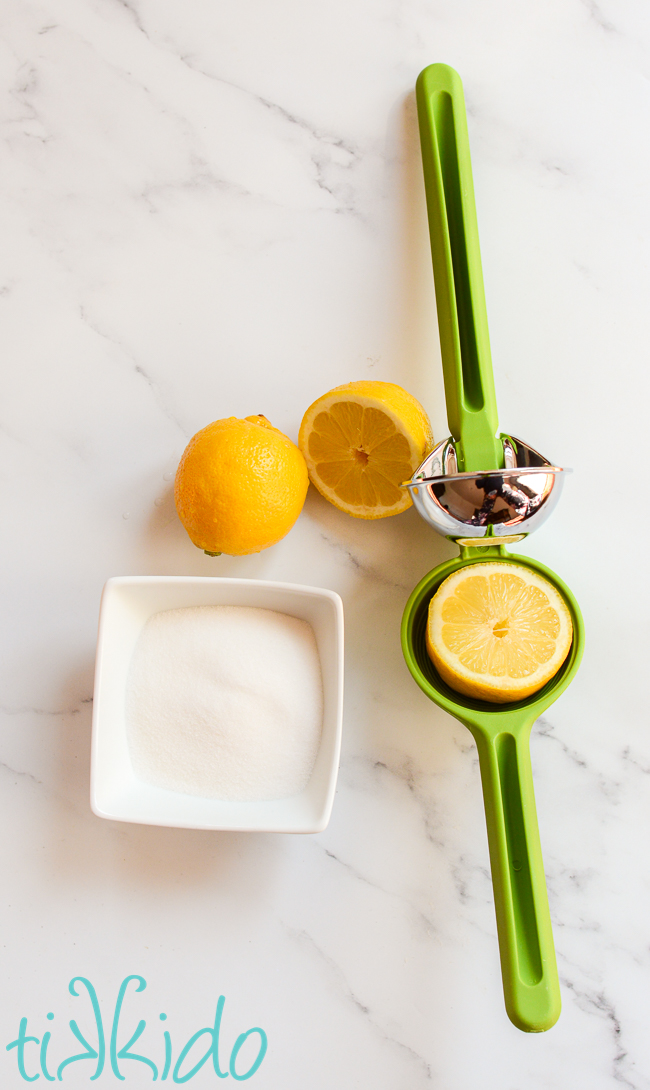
[416,64,504,471]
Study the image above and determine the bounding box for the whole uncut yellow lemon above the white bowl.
[174,416,309,556]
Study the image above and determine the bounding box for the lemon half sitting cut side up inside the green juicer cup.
[426,561,573,704]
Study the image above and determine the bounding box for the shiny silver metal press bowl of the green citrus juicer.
[402,435,570,545]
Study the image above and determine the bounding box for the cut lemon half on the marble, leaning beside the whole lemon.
[298,382,433,519]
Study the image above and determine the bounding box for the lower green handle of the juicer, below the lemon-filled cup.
[468,716,561,1033]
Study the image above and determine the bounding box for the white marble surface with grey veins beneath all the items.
[0,0,650,1090]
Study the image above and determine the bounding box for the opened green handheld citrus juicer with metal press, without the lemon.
[401,64,585,1032]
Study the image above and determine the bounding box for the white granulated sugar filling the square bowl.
[127,606,323,801]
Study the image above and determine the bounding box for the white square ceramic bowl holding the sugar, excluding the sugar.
[91,576,344,833]
